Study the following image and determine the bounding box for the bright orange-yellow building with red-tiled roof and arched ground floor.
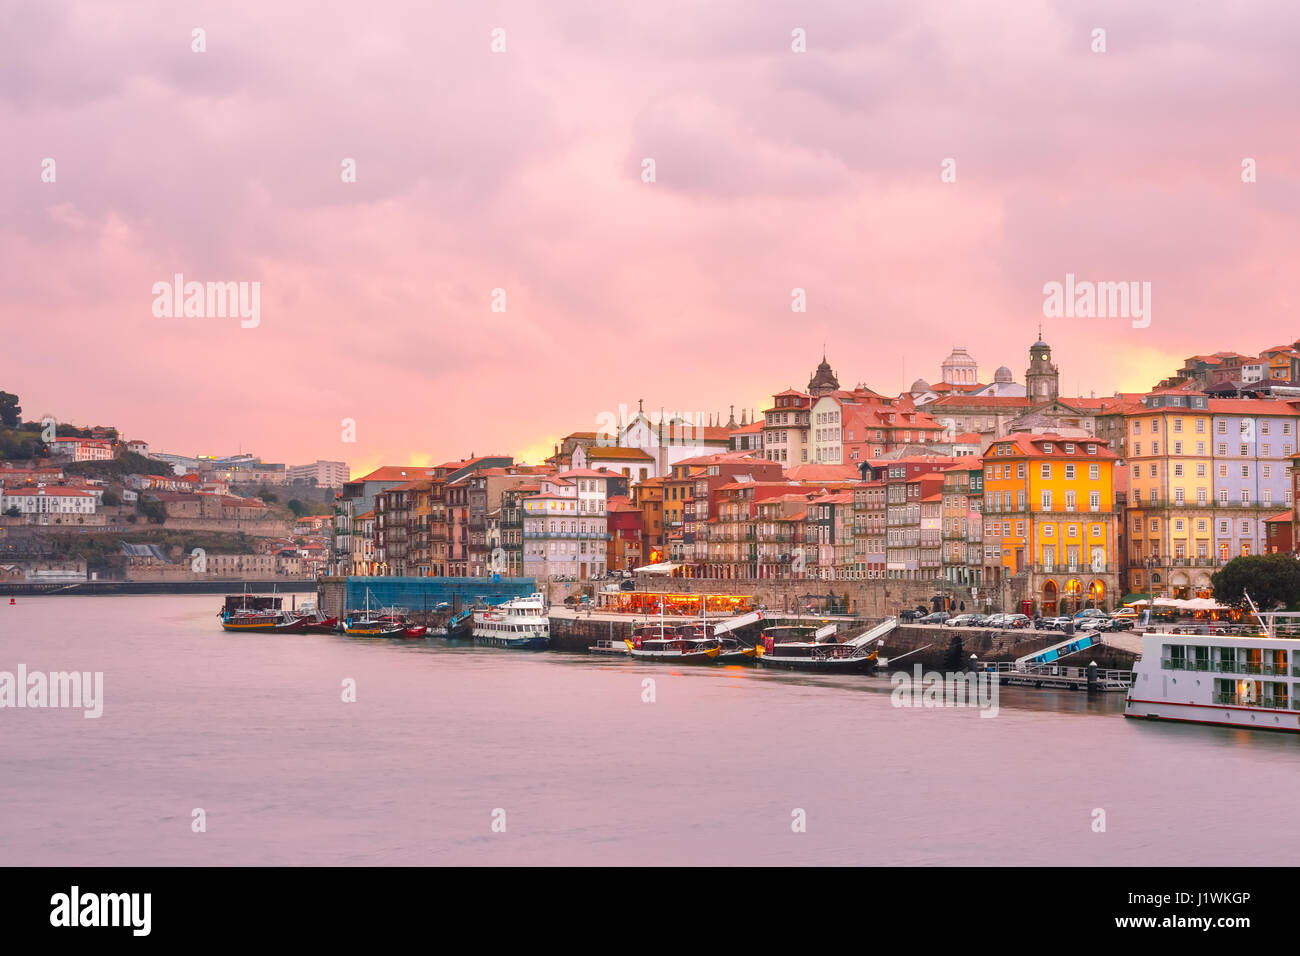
[984,434,1119,617]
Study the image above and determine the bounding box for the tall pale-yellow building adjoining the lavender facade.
[1125,389,1214,597]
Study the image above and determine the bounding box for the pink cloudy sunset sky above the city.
[0,0,1300,470]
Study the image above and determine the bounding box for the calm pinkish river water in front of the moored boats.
[0,596,1300,865]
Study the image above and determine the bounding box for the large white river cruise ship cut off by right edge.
[1125,604,1300,732]
